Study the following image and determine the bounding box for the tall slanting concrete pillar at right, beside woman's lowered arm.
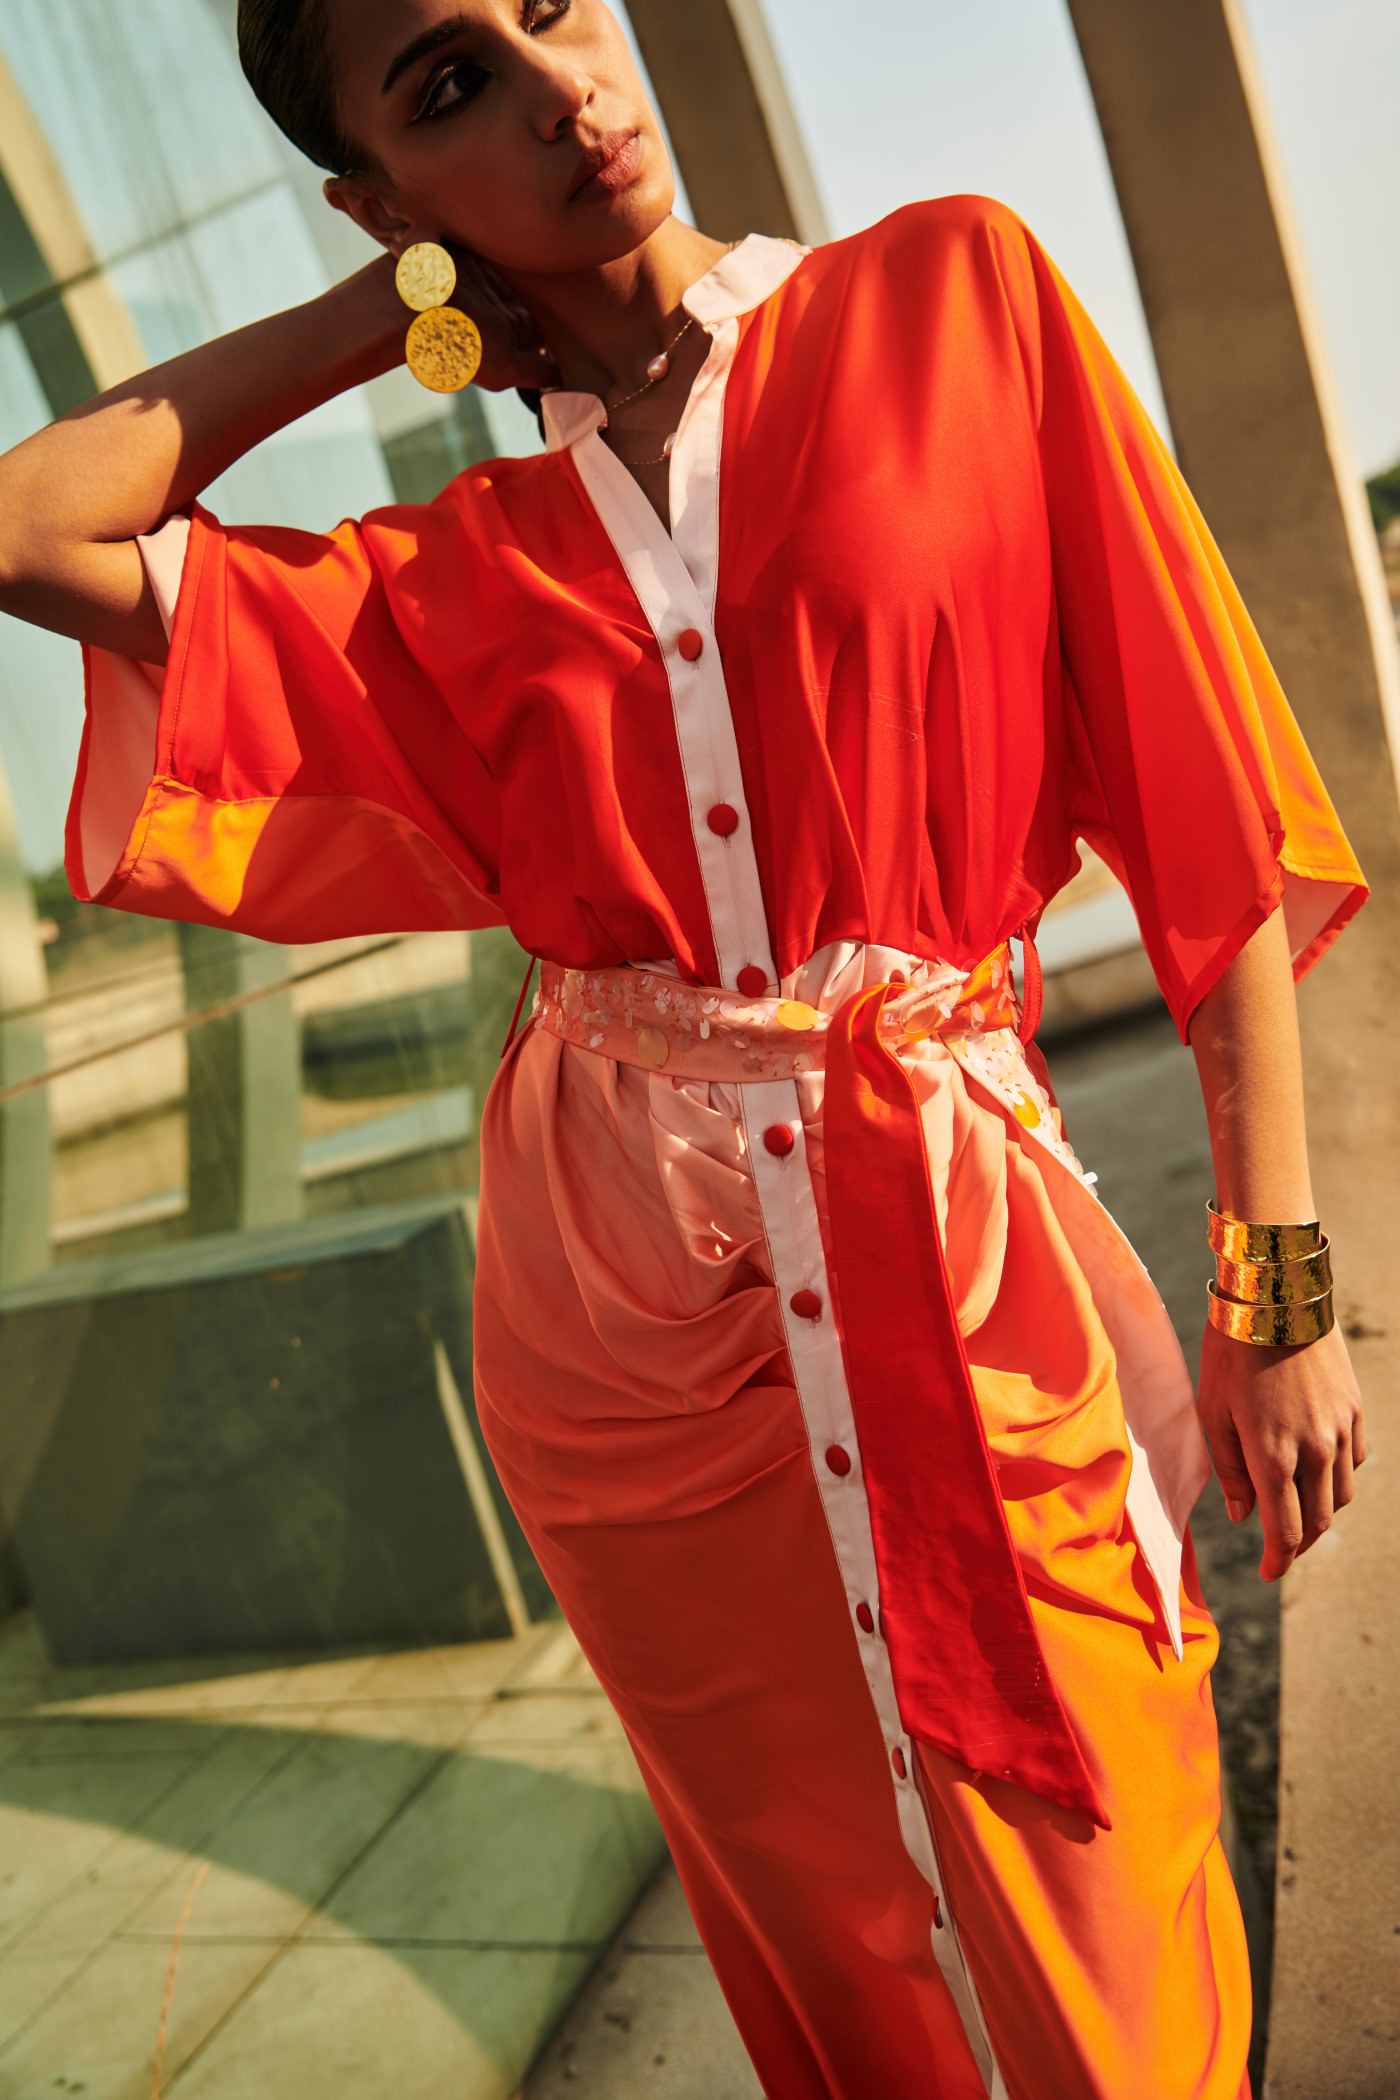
[1068,0,1400,2100]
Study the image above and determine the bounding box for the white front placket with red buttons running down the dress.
[558,249,1005,2100]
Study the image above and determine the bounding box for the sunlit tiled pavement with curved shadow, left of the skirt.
[0,1613,684,2100]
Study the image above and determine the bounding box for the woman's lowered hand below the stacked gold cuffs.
[1199,1323,1366,1581]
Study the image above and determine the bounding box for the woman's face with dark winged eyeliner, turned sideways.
[327,0,676,275]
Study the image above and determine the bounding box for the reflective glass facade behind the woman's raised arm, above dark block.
[0,0,554,1283]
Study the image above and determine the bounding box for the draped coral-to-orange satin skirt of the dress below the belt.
[476,945,1249,2100]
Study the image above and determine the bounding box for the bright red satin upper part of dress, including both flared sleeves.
[67,195,1364,1050]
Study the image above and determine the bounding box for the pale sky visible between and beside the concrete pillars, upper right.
[764,0,1400,475]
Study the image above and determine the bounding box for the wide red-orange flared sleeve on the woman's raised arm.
[65,500,504,941]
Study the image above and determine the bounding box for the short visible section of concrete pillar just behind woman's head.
[628,0,827,242]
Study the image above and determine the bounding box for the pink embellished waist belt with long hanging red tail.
[512,941,1110,1829]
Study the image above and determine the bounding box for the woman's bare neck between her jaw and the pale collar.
[510,216,726,401]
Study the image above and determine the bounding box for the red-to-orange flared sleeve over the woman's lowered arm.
[989,206,1366,1037]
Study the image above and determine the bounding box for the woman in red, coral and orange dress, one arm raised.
[0,0,1364,2100]
